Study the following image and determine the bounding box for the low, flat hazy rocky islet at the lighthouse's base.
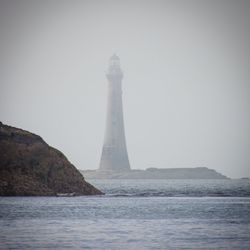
[81,167,228,179]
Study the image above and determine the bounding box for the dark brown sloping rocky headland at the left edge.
[0,123,102,196]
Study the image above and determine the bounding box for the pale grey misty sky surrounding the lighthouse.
[0,0,250,178]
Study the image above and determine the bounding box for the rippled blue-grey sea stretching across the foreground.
[0,179,250,250]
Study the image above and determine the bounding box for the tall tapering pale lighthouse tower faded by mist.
[99,54,130,172]
